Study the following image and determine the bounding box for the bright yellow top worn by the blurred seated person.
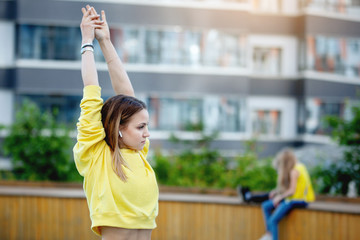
[286,163,315,202]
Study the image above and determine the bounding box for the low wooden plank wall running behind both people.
[0,189,360,240]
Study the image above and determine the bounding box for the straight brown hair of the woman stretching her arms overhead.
[101,95,146,182]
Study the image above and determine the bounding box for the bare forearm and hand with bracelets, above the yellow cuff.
[80,8,101,86]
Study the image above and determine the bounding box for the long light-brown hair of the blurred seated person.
[274,148,296,193]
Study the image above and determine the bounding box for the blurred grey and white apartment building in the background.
[0,0,360,161]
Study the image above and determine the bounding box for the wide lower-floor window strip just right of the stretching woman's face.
[147,96,245,132]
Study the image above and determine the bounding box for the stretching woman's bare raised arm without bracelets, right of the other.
[88,5,135,97]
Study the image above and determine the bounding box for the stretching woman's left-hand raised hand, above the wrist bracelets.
[80,5,103,43]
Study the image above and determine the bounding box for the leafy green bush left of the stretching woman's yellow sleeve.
[3,100,79,181]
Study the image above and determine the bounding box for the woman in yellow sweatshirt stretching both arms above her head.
[73,6,159,240]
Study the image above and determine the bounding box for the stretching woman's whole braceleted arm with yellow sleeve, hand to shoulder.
[73,8,105,176]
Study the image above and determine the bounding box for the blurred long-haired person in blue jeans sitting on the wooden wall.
[261,149,315,240]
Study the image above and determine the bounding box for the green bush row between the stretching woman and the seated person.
[154,134,276,191]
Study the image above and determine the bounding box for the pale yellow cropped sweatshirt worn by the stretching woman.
[73,86,159,235]
